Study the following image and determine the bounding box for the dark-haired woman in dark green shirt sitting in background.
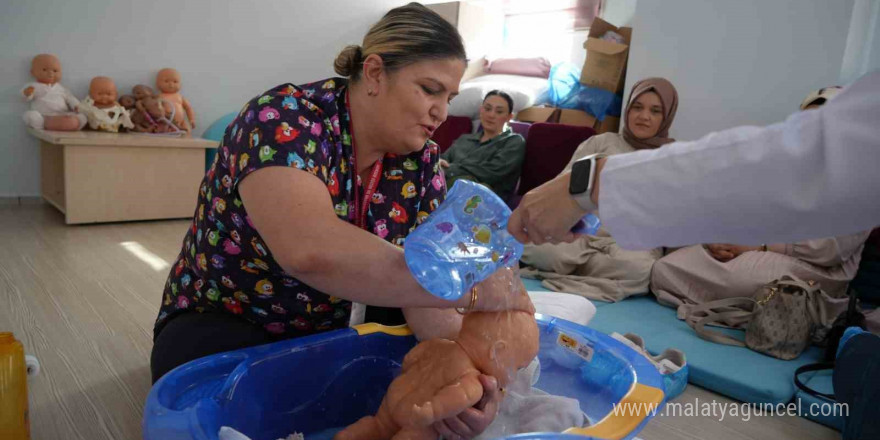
[440,90,526,200]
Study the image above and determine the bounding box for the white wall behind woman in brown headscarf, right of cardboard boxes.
[627,0,855,140]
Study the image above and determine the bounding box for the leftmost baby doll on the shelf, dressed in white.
[21,53,87,131]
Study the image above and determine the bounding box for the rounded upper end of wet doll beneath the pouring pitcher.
[458,311,538,387]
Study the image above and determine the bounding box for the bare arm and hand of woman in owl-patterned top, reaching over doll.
[238,167,534,311]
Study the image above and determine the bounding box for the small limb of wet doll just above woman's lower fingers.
[411,373,483,425]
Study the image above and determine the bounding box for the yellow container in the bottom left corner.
[0,332,31,440]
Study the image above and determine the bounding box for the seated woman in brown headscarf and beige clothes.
[522,78,678,302]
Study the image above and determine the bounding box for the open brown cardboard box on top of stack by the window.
[581,18,632,93]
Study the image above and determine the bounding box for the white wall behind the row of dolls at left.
[0,0,407,197]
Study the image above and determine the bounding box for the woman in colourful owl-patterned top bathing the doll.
[151,3,534,438]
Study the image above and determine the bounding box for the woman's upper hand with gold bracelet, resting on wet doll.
[456,267,535,313]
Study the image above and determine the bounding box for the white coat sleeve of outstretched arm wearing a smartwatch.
[599,72,880,249]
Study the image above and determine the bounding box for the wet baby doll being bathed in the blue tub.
[333,311,538,440]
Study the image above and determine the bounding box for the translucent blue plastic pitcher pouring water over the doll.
[404,180,523,301]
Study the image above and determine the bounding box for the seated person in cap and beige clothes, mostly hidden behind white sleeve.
[651,87,870,324]
